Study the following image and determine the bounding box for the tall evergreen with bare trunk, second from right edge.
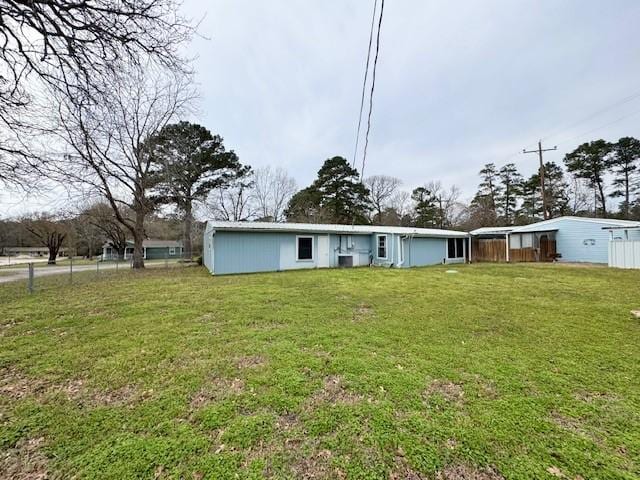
[564,140,612,217]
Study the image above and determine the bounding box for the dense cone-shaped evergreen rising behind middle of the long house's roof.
[286,157,371,224]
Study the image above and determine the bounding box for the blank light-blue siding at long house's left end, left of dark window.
[213,231,281,274]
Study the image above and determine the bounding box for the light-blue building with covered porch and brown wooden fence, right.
[470,216,640,263]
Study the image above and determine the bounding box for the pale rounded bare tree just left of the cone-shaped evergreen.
[252,166,298,222]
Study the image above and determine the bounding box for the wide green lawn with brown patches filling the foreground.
[0,265,640,480]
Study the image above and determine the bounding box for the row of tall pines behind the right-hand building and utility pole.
[469,137,640,226]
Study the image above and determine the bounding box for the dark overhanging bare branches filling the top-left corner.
[0,0,193,186]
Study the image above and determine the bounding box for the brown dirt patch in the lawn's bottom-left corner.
[0,437,48,480]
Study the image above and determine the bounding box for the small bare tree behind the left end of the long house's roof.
[205,181,255,222]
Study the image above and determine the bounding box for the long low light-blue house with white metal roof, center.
[203,221,468,275]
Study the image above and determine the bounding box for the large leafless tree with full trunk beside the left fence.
[53,65,195,268]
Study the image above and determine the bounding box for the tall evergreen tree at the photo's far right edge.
[609,137,640,218]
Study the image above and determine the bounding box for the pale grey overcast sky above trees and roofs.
[5,0,640,217]
